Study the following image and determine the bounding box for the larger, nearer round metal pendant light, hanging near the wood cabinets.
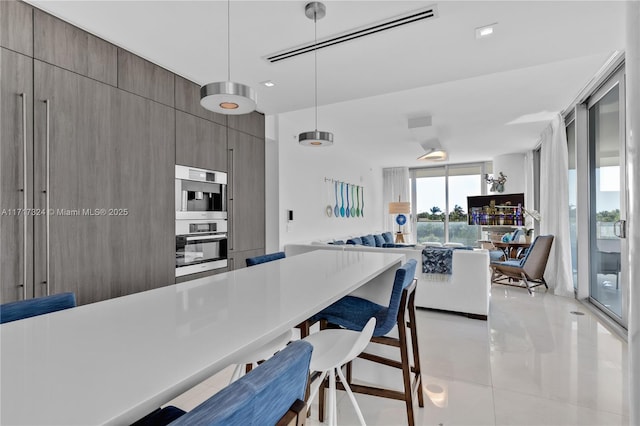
[200,0,257,115]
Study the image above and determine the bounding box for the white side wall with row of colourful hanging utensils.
[267,113,383,247]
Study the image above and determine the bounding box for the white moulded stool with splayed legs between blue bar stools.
[303,317,376,426]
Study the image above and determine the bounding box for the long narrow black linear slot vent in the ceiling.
[265,5,438,64]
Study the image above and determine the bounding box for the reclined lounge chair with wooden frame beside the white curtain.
[489,235,553,294]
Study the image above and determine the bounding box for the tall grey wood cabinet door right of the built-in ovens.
[227,129,265,252]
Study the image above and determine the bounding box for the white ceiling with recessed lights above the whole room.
[30,0,625,166]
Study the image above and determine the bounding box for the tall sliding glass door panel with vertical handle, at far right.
[587,70,628,326]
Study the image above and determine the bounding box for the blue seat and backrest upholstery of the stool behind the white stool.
[312,259,417,337]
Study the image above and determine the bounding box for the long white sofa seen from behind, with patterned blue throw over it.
[284,242,491,320]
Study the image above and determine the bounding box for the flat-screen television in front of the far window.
[467,193,524,226]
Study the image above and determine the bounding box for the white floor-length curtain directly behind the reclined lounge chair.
[540,114,573,297]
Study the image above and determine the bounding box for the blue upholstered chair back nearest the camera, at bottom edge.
[135,340,313,426]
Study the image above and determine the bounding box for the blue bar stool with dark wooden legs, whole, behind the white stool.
[312,259,424,425]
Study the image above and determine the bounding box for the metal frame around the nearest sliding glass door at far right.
[584,66,629,328]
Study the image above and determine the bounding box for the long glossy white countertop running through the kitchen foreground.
[0,250,404,425]
